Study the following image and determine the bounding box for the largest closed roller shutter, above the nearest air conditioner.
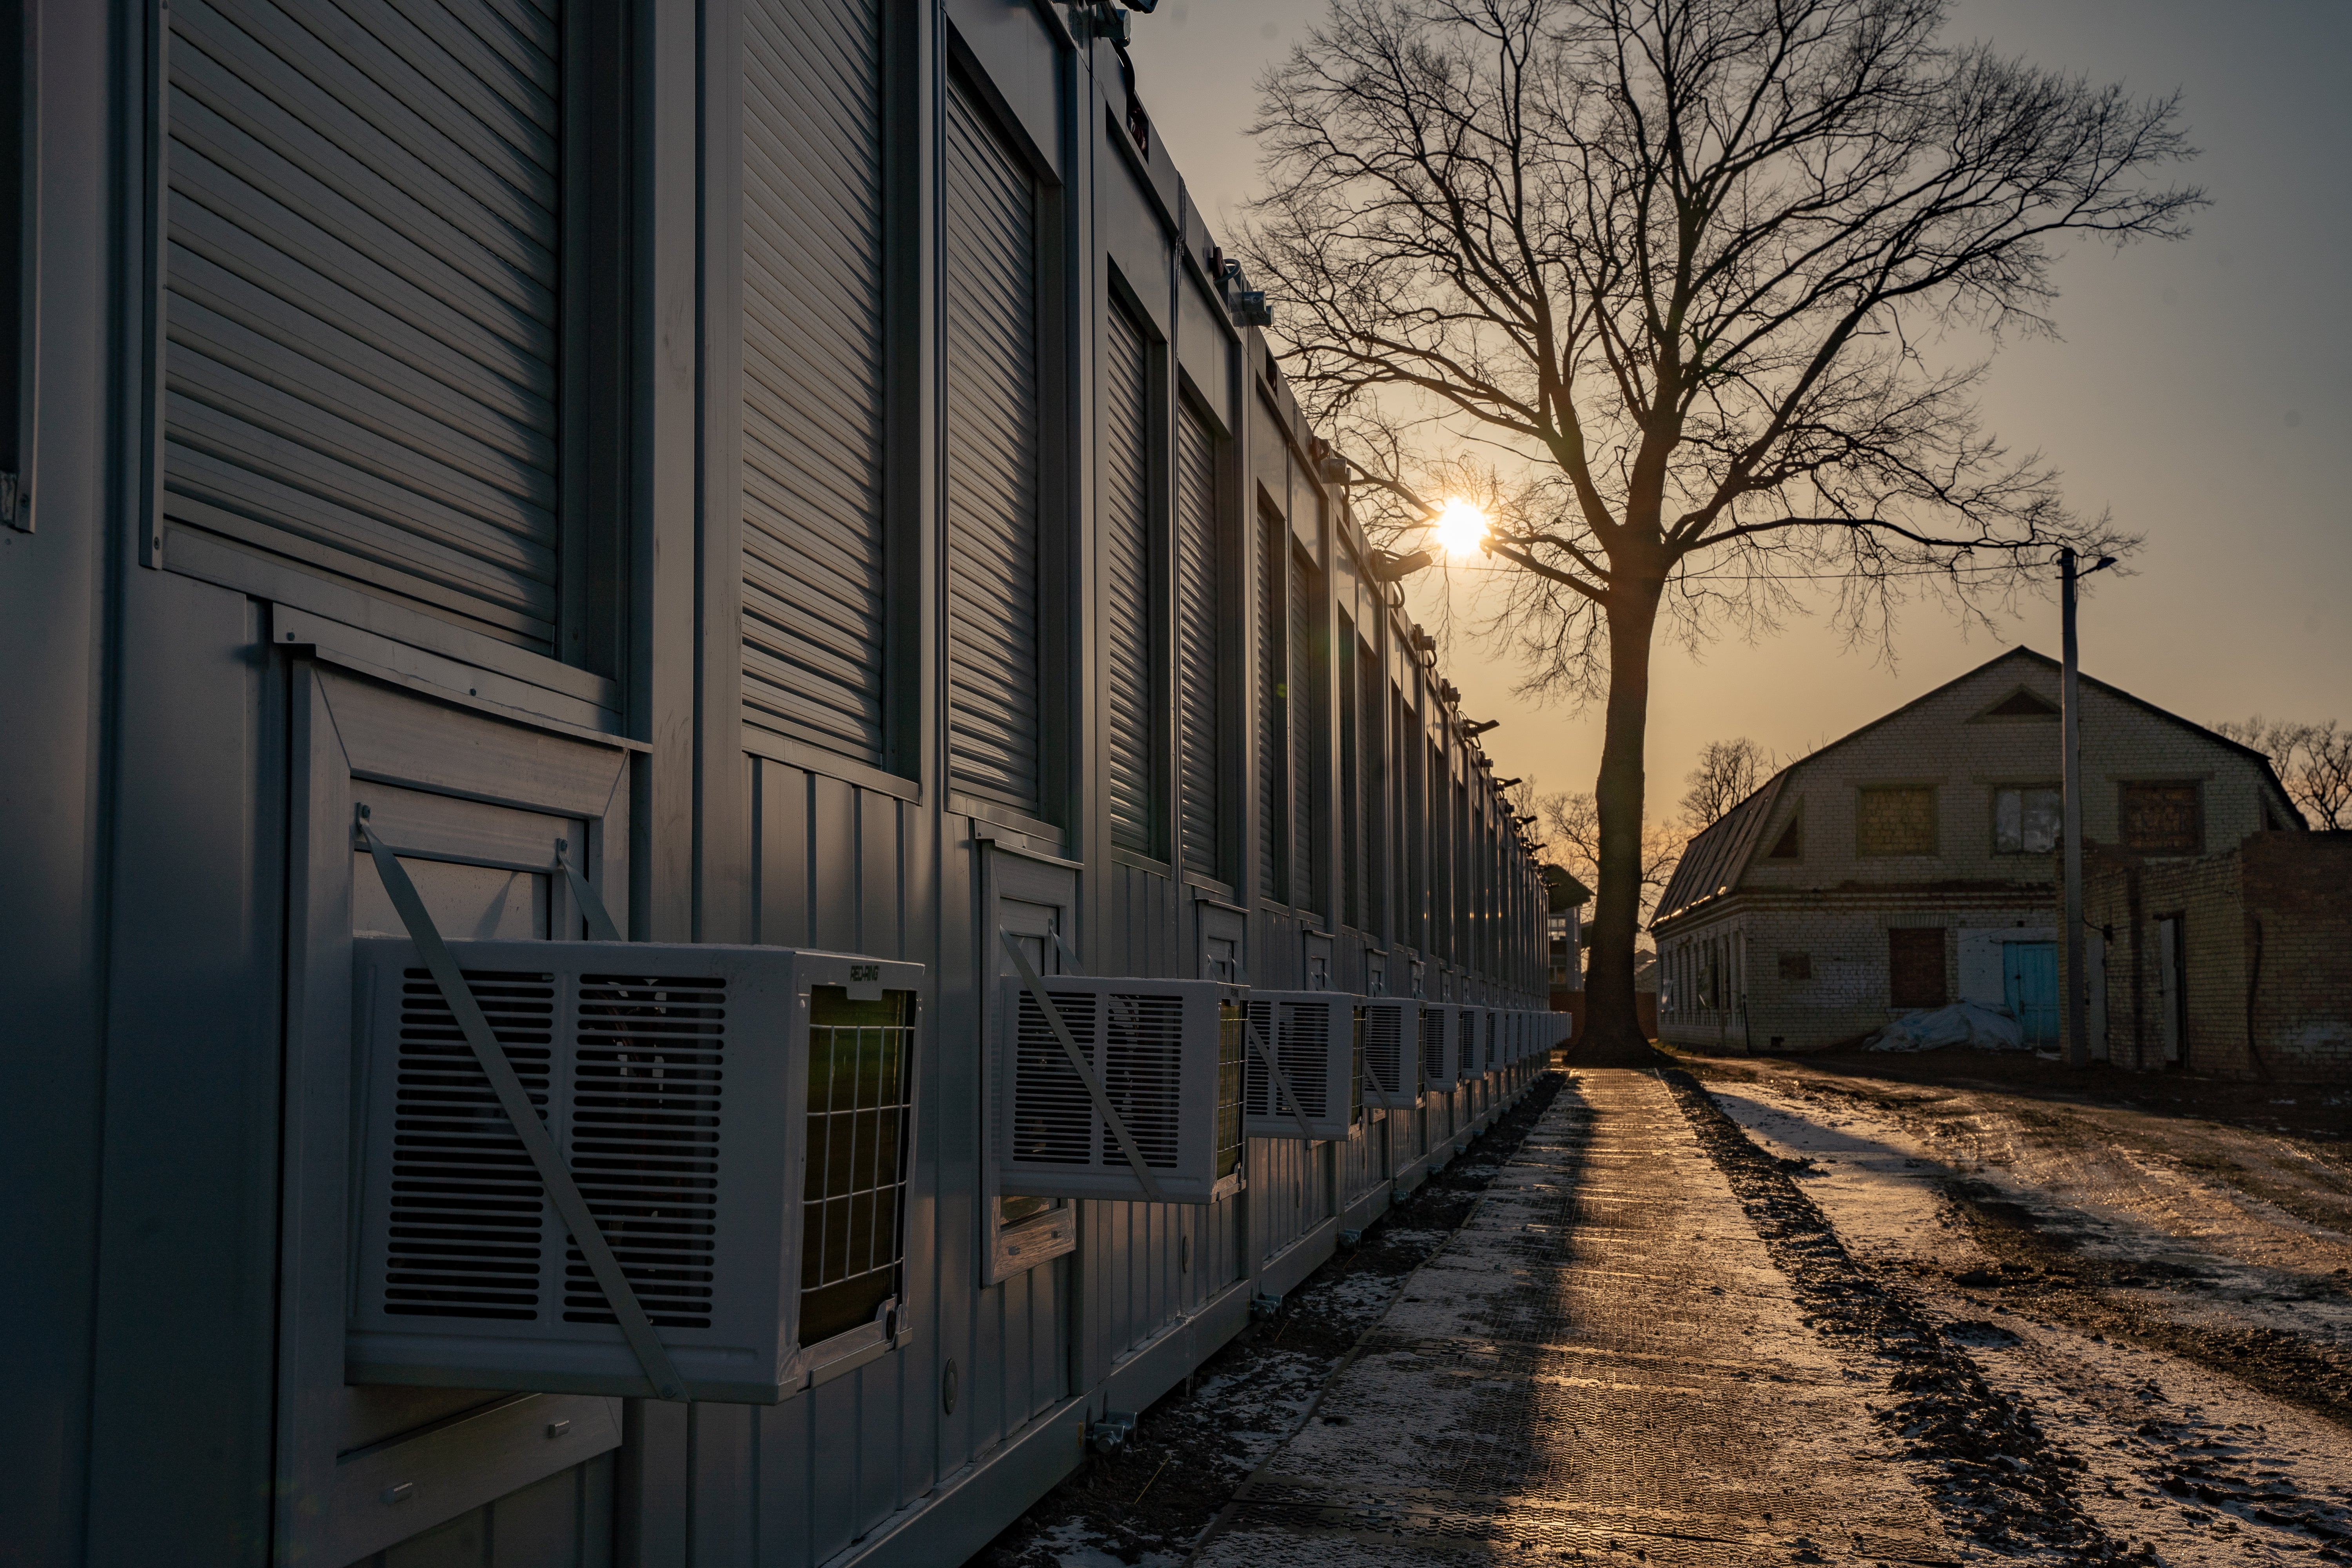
[165,0,562,653]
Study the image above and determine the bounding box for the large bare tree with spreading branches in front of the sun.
[1242,0,2201,1049]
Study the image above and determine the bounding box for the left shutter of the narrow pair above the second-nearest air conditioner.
[1103,306,1162,856]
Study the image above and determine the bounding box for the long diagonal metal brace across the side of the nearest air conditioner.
[358,806,687,1399]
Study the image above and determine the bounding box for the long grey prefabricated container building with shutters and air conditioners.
[0,0,1545,1568]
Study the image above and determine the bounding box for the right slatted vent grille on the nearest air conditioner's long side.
[564,976,727,1328]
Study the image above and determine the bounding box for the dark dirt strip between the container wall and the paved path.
[967,1077,1559,1568]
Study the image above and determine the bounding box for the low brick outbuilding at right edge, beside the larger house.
[2084,830,2352,1084]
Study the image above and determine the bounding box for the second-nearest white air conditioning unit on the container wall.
[997,976,1244,1203]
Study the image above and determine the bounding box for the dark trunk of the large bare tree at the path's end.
[1578,578,1663,1065]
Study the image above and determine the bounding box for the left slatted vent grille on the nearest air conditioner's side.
[383,969,555,1321]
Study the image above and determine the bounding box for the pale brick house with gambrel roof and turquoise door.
[1651,649,2303,1051]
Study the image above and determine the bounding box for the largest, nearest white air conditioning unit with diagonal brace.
[346,938,922,1403]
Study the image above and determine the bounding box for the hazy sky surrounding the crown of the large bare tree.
[1134,0,2352,813]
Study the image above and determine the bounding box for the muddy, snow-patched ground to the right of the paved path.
[1677,1034,2352,1568]
